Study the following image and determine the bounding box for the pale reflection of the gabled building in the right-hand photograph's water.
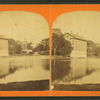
[63,58,87,82]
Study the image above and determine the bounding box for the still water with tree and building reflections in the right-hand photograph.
[52,58,100,84]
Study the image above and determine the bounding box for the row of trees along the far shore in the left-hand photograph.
[8,38,49,54]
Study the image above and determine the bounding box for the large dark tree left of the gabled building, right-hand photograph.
[52,29,72,56]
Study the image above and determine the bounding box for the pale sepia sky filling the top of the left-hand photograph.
[0,11,49,46]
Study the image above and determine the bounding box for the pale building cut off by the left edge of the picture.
[0,35,9,57]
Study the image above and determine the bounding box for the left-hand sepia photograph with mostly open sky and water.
[0,11,50,91]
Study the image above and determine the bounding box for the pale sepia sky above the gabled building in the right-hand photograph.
[52,11,100,43]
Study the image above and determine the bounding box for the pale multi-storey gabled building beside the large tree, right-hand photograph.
[64,33,87,57]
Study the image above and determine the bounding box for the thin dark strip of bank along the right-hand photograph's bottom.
[53,84,100,91]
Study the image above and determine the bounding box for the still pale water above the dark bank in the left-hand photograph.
[0,56,50,84]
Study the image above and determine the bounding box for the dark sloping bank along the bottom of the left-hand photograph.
[0,80,49,91]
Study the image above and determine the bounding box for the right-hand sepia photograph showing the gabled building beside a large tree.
[51,11,100,91]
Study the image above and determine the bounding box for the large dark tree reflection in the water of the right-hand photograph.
[51,60,71,81]
